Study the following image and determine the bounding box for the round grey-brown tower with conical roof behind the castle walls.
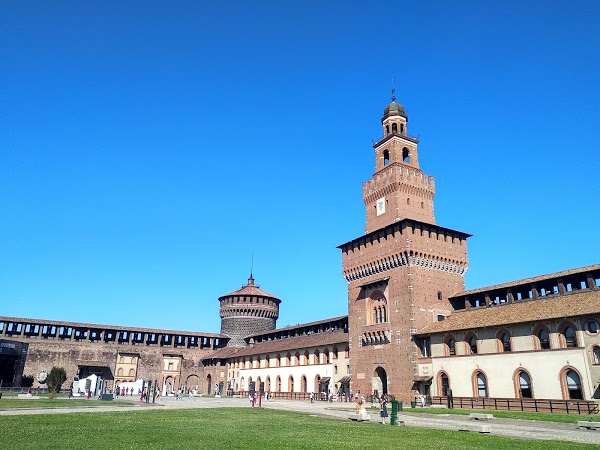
[219,274,281,347]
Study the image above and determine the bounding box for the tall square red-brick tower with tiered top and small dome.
[338,90,470,401]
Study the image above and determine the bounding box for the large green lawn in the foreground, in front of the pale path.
[0,408,589,450]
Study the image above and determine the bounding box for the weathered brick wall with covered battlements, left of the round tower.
[0,317,227,390]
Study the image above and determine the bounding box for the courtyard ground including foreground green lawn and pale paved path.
[0,397,600,449]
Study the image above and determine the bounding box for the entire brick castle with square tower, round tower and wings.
[0,96,600,400]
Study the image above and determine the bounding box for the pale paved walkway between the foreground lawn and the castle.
[0,397,600,445]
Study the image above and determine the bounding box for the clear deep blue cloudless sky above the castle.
[0,0,600,332]
